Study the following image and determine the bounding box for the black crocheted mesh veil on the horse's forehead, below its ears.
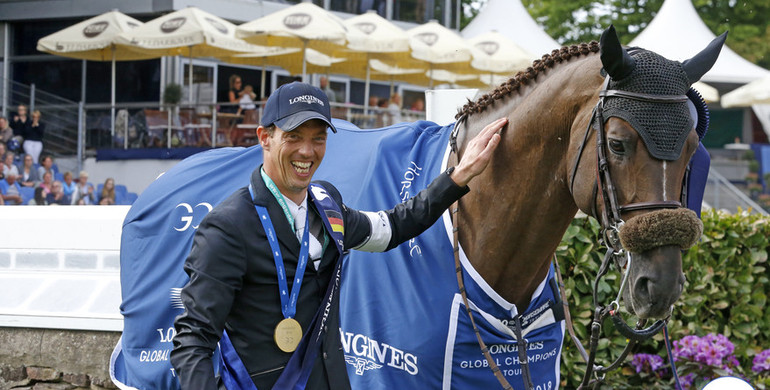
[604,49,702,160]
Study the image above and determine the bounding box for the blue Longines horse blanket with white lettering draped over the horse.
[110,120,704,390]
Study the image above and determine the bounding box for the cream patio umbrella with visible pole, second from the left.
[118,7,256,103]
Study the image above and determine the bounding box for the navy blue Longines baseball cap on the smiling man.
[260,81,337,133]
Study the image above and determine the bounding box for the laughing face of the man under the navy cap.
[258,119,327,202]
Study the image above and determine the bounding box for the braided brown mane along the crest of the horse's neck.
[455,41,599,119]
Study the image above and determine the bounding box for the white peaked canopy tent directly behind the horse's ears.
[629,0,770,84]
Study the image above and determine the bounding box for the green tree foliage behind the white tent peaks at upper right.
[462,0,770,68]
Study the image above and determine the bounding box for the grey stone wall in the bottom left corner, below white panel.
[0,327,120,390]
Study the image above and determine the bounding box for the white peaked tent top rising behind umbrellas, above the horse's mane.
[461,0,562,58]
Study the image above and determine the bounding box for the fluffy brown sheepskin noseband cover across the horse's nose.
[619,208,703,253]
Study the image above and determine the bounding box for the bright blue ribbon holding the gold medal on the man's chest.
[249,185,310,318]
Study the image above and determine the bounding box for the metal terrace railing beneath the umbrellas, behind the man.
[0,78,425,170]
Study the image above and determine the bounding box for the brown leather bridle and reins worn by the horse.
[449,71,689,389]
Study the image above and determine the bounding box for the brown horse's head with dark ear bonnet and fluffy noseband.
[572,27,726,318]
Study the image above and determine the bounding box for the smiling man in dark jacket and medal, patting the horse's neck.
[171,82,507,390]
